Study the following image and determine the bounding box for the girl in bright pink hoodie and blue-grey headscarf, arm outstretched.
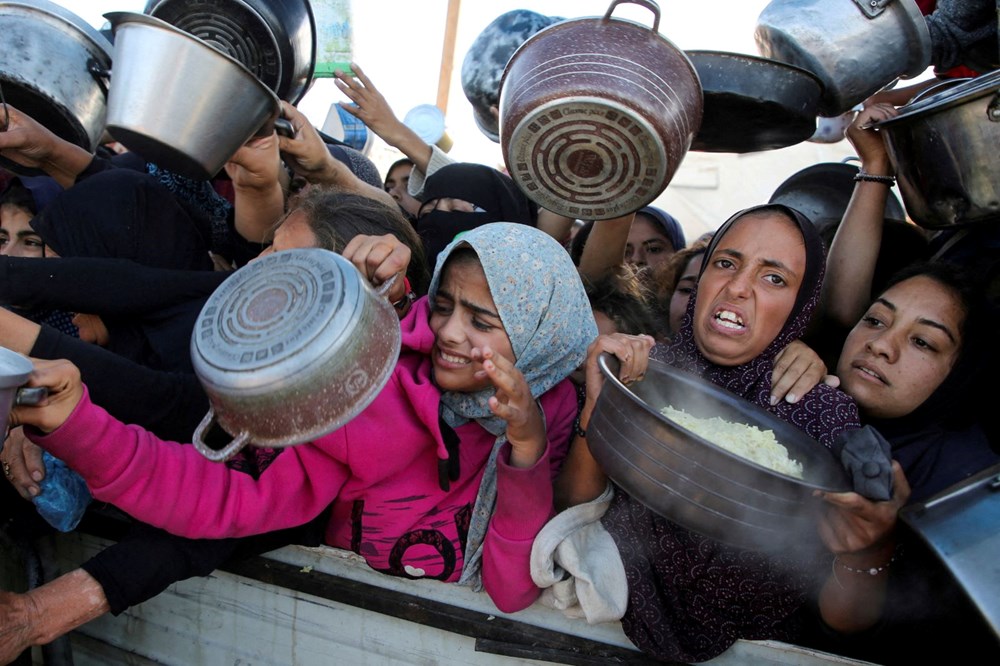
[5,223,596,652]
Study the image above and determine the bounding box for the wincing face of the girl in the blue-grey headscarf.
[430,257,516,393]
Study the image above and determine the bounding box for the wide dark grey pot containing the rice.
[587,355,851,550]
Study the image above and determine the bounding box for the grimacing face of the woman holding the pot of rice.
[694,213,806,366]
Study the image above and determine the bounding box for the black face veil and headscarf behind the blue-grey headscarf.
[417,162,536,269]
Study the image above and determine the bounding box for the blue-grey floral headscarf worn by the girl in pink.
[429,222,597,588]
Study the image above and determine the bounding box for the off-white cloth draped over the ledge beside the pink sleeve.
[531,484,628,624]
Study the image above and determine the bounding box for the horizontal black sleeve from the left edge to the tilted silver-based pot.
[0,257,231,316]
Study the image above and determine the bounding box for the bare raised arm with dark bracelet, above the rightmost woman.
[823,104,897,327]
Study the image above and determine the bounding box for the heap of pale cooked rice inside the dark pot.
[660,405,802,479]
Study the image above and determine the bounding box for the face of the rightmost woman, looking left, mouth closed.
[837,276,965,419]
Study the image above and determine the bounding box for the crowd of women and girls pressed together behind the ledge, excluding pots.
[0,2,1000,663]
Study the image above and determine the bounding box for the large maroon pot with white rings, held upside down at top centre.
[500,0,702,220]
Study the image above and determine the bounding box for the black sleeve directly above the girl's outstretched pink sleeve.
[31,326,208,442]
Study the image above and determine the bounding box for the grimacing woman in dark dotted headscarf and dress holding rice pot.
[557,204,859,661]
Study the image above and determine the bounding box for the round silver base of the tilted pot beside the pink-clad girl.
[191,248,367,387]
